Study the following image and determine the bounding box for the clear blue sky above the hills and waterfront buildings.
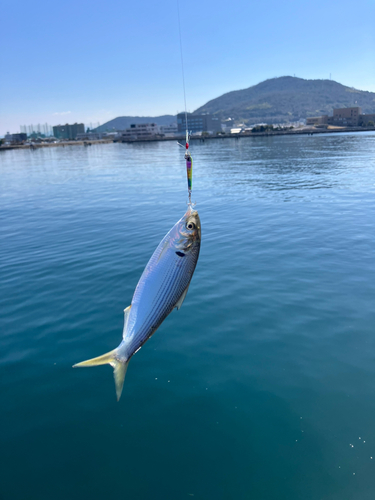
[0,0,375,136]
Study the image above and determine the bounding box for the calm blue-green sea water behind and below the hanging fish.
[0,133,375,500]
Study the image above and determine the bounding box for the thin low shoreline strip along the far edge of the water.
[0,127,375,151]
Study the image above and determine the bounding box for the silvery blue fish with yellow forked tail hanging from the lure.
[73,205,201,401]
